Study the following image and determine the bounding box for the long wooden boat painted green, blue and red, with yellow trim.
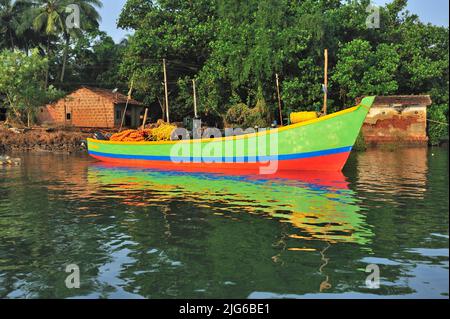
[88,97,375,174]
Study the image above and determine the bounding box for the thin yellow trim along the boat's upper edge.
[87,103,367,145]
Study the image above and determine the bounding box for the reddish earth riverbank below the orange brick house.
[0,127,92,154]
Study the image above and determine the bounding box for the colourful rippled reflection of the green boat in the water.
[88,164,371,251]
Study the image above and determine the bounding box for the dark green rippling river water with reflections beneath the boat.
[0,148,449,298]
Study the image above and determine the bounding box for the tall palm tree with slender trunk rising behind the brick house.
[32,0,102,83]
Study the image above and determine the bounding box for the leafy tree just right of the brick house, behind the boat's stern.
[118,0,215,120]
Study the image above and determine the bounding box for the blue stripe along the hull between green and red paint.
[89,146,352,163]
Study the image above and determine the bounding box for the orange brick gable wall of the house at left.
[38,88,114,128]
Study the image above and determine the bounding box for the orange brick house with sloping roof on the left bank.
[37,87,145,128]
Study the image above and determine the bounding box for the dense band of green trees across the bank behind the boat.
[0,0,449,142]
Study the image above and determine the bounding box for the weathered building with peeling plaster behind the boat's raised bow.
[362,95,432,145]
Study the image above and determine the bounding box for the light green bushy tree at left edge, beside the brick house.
[0,50,62,126]
